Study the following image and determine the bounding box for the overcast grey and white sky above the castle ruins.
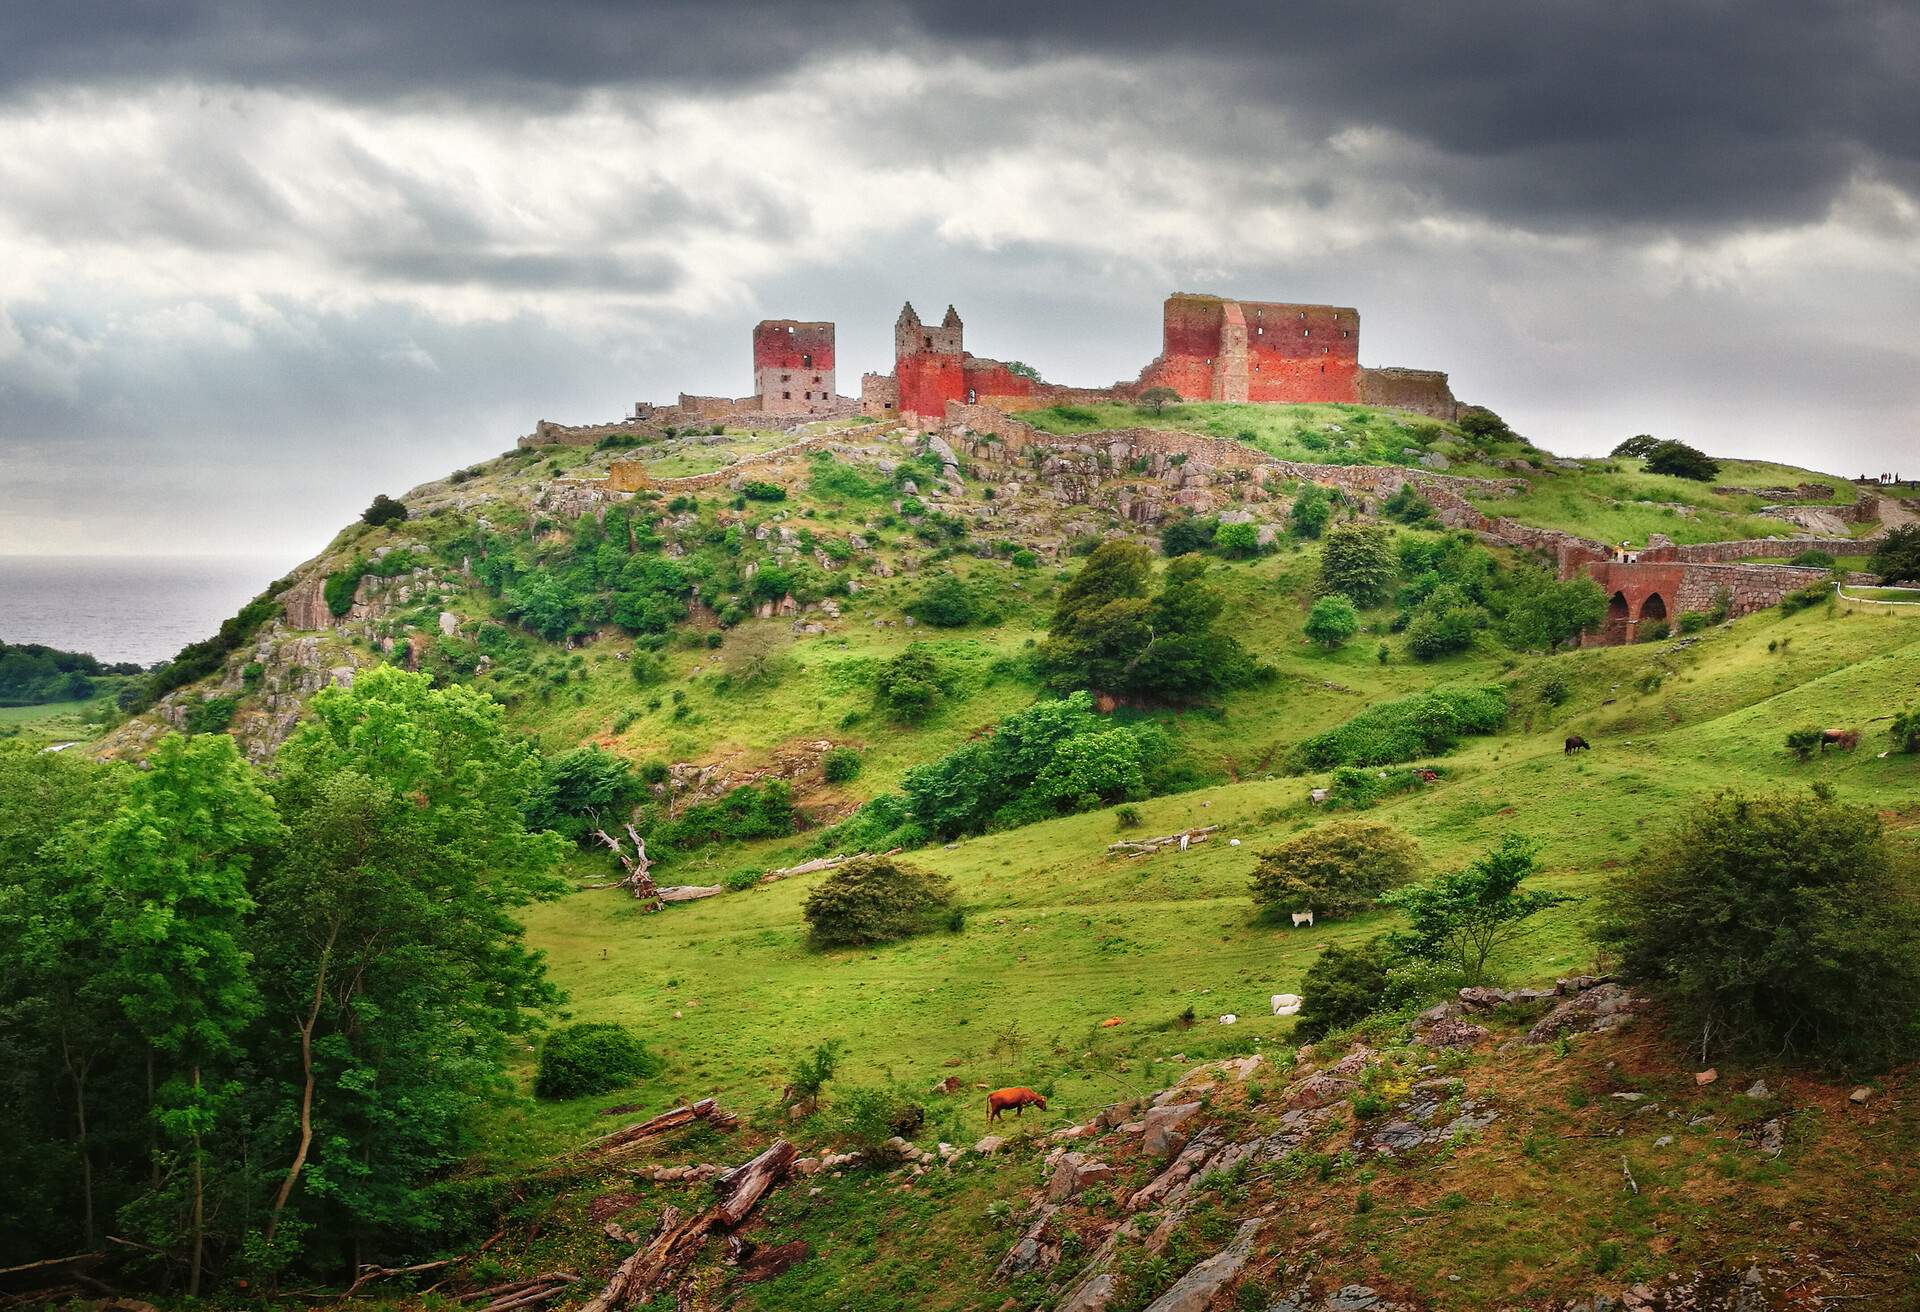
[0,0,1920,561]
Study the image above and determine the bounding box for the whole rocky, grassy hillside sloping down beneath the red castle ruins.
[26,405,1920,1312]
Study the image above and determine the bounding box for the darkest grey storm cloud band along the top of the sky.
[0,0,1920,227]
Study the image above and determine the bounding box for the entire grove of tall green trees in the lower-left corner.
[0,668,564,1289]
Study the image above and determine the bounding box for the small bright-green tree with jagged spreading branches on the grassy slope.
[1380,834,1569,984]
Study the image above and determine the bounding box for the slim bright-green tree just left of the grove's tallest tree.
[86,734,280,1295]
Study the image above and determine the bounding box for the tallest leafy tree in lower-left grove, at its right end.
[255,667,566,1247]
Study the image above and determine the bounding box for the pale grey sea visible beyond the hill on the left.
[0,555,300,665]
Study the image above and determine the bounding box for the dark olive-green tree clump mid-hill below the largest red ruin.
[1041,542,1254,703]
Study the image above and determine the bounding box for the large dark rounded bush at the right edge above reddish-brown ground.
[1601,791,1920,1072]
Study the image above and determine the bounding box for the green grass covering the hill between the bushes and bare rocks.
[60,405,1920,1312]
